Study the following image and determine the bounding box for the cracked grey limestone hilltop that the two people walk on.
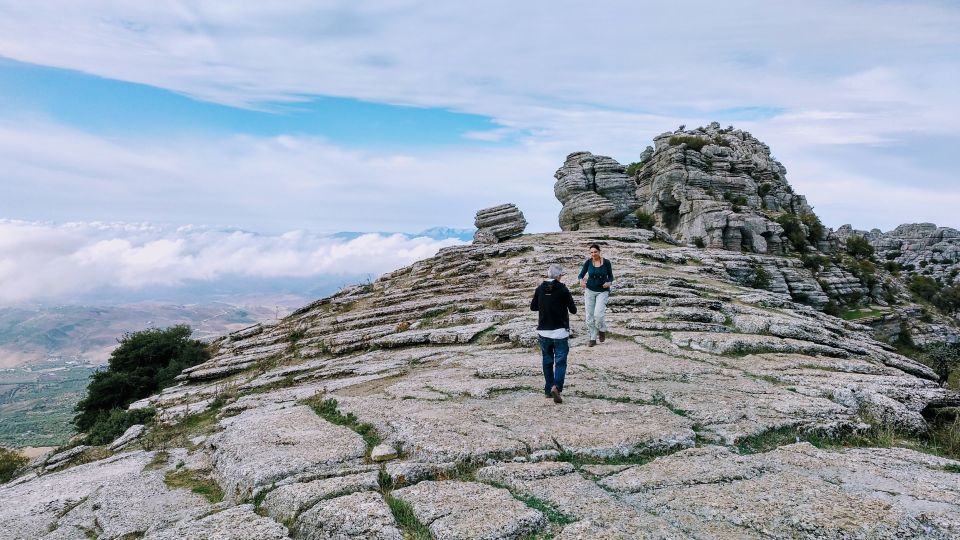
[0,226,960,539]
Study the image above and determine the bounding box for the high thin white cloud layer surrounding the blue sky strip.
[0,0,960,236]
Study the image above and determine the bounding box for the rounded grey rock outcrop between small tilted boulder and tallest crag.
[553,152,639,231]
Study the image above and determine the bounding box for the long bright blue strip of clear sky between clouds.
[0,59,499,150]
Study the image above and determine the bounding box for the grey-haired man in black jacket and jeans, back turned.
[530,264,577,403]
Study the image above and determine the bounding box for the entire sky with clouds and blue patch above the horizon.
[0,0,960,305]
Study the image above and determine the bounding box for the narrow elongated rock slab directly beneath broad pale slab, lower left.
[260,472,378,522]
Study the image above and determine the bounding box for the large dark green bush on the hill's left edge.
[73,325,210,431]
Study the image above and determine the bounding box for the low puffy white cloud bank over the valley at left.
[0,220,461,304]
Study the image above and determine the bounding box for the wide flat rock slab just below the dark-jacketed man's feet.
[340,392,695,462]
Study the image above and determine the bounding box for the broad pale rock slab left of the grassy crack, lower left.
[206,405,366,500]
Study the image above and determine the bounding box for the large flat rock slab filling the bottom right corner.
[600,443,960,539]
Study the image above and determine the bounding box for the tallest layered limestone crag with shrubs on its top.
[636,122,829,254]
